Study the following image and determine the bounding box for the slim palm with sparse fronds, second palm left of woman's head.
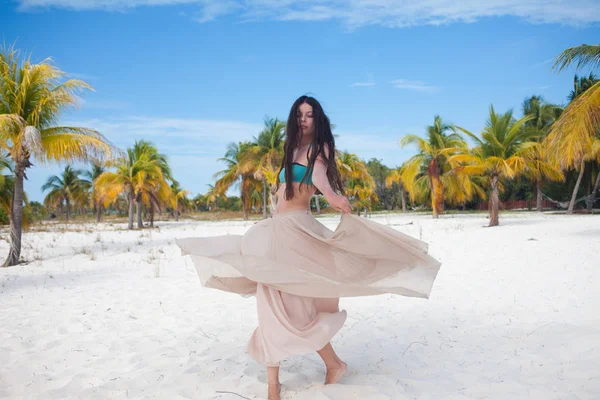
[213,142,256,220]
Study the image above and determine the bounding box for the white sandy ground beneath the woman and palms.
[0,214,600,400]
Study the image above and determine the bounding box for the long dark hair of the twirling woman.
[277,96,346,200]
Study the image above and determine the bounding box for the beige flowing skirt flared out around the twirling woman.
[176,210,440,365]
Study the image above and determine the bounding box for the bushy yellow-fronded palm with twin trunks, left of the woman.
[96,142,166,229]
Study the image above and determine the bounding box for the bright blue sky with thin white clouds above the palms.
[0,0,600,201]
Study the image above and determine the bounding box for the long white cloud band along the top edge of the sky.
[17,0,600,28]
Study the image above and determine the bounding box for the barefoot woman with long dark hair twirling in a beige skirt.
[177,96,440,400]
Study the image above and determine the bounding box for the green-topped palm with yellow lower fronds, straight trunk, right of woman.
[450,106,537,226]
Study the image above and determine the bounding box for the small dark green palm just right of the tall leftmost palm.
[42,165,92,222]
